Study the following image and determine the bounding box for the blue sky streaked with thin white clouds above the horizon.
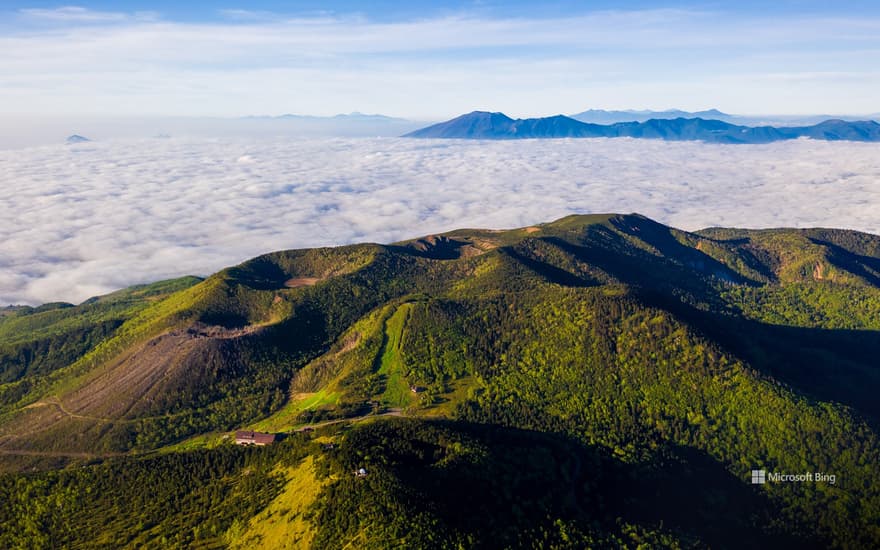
[0,0,880,119]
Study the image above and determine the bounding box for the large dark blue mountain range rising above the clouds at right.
[404,111,880,144]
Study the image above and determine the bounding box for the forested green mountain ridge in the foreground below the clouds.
[0,214,880,548]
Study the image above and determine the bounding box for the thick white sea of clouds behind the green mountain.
[0,138,880,305]
